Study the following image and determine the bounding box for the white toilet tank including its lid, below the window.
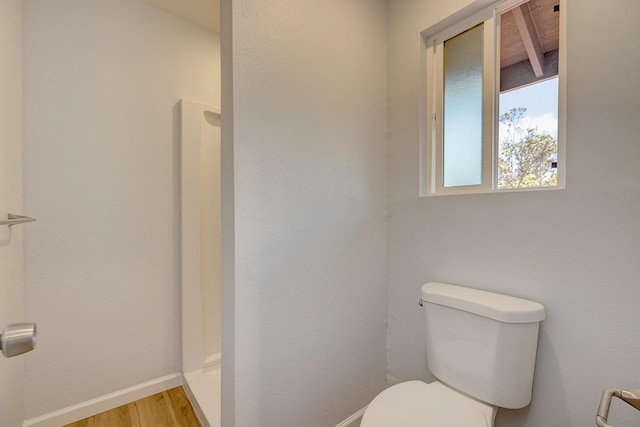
[422,283,545,409]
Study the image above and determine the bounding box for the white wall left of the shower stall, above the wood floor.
[24,0,220,417]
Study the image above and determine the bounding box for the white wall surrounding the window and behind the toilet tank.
[388,0,640,427]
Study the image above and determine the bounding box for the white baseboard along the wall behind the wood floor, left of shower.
[23,373,182,427]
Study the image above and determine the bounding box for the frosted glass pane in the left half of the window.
[443,24,484,187]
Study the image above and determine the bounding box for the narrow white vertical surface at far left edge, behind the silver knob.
[0,0,26,426]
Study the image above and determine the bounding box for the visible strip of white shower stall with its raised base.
[180,99,222,427]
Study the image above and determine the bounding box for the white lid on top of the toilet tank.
[422,282,545,323]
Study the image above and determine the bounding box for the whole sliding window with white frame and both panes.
[422,0,565,195]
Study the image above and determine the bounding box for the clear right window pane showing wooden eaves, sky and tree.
[497,0,560,188]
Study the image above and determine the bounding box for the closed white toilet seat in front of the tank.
[360,381,497,427]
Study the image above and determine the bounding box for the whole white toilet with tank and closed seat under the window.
[360,283,545,427]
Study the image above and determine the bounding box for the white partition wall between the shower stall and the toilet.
[230,0,387,427]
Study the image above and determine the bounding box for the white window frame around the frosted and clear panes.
[420,0,568,196]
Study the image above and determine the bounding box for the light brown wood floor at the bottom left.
[63,387,201,427]
